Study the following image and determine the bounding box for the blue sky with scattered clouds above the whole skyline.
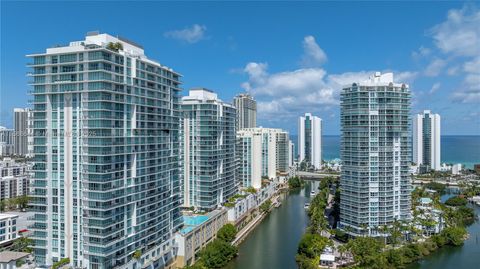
[0,1,480,135]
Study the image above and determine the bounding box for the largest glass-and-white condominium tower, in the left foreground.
[28,32,182,269]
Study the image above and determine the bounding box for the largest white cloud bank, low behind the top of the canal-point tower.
[242,62,417,124]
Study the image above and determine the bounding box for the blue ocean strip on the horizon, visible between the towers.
[290,135,480,169]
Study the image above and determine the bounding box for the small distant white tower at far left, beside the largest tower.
[13,108,30,156]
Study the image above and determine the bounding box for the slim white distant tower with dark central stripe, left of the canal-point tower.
[298,113,322,169]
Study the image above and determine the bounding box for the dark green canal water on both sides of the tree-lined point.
[225,182,480,269]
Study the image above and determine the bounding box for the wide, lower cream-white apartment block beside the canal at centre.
[236,128,290,189]
